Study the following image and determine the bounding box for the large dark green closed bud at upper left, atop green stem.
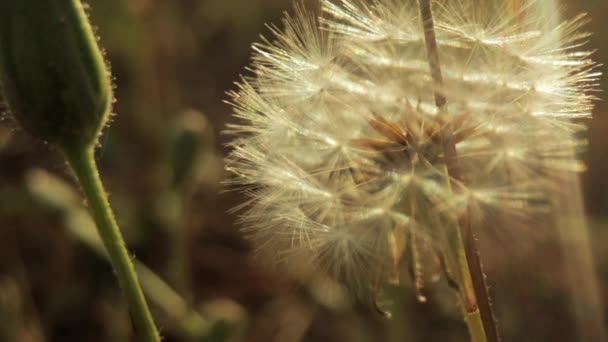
[0,0,112,148]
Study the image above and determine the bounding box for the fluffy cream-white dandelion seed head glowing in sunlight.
[227,0,600,299]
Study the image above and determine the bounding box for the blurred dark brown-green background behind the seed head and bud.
[0,0,608,342]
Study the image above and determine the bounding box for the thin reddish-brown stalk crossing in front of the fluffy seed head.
[419,0,500,342]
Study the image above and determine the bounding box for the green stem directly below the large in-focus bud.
[62,147,160,342]
